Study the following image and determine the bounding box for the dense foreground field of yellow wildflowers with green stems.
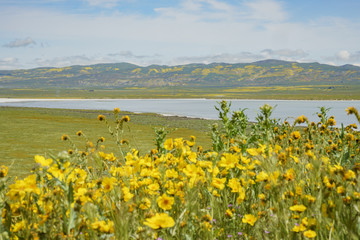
[0,101,360,240]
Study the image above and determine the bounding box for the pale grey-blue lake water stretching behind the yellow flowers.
[0,98,360,126]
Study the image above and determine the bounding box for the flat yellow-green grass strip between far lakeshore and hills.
[0,85,360,100]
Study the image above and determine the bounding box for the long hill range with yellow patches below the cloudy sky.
[0,60,360,89]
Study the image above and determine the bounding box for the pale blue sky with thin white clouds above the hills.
[0,0,360,70]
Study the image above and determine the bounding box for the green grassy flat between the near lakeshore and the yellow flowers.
[0,106,214,176]
